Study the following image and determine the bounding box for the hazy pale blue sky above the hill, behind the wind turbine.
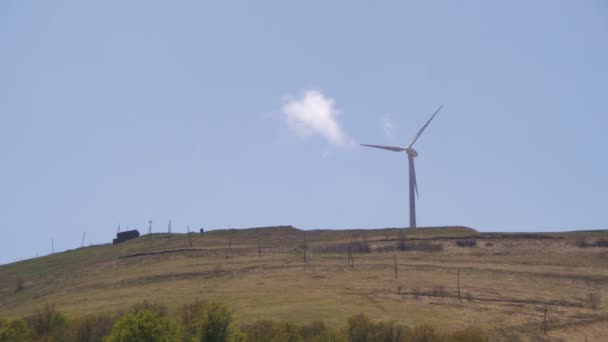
[0,0,608,263]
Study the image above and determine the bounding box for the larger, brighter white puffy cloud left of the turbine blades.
[282,90,352,146]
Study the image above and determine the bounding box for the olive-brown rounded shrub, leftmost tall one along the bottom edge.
[29,303,69,341]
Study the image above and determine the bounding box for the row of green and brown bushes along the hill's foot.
[0,300,488,342]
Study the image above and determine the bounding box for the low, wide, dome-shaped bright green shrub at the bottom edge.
[106,310,177,342]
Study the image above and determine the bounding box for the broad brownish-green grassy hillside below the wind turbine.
[0,226,608,340]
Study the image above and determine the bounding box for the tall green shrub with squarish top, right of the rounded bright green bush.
[181,300,232,342]
